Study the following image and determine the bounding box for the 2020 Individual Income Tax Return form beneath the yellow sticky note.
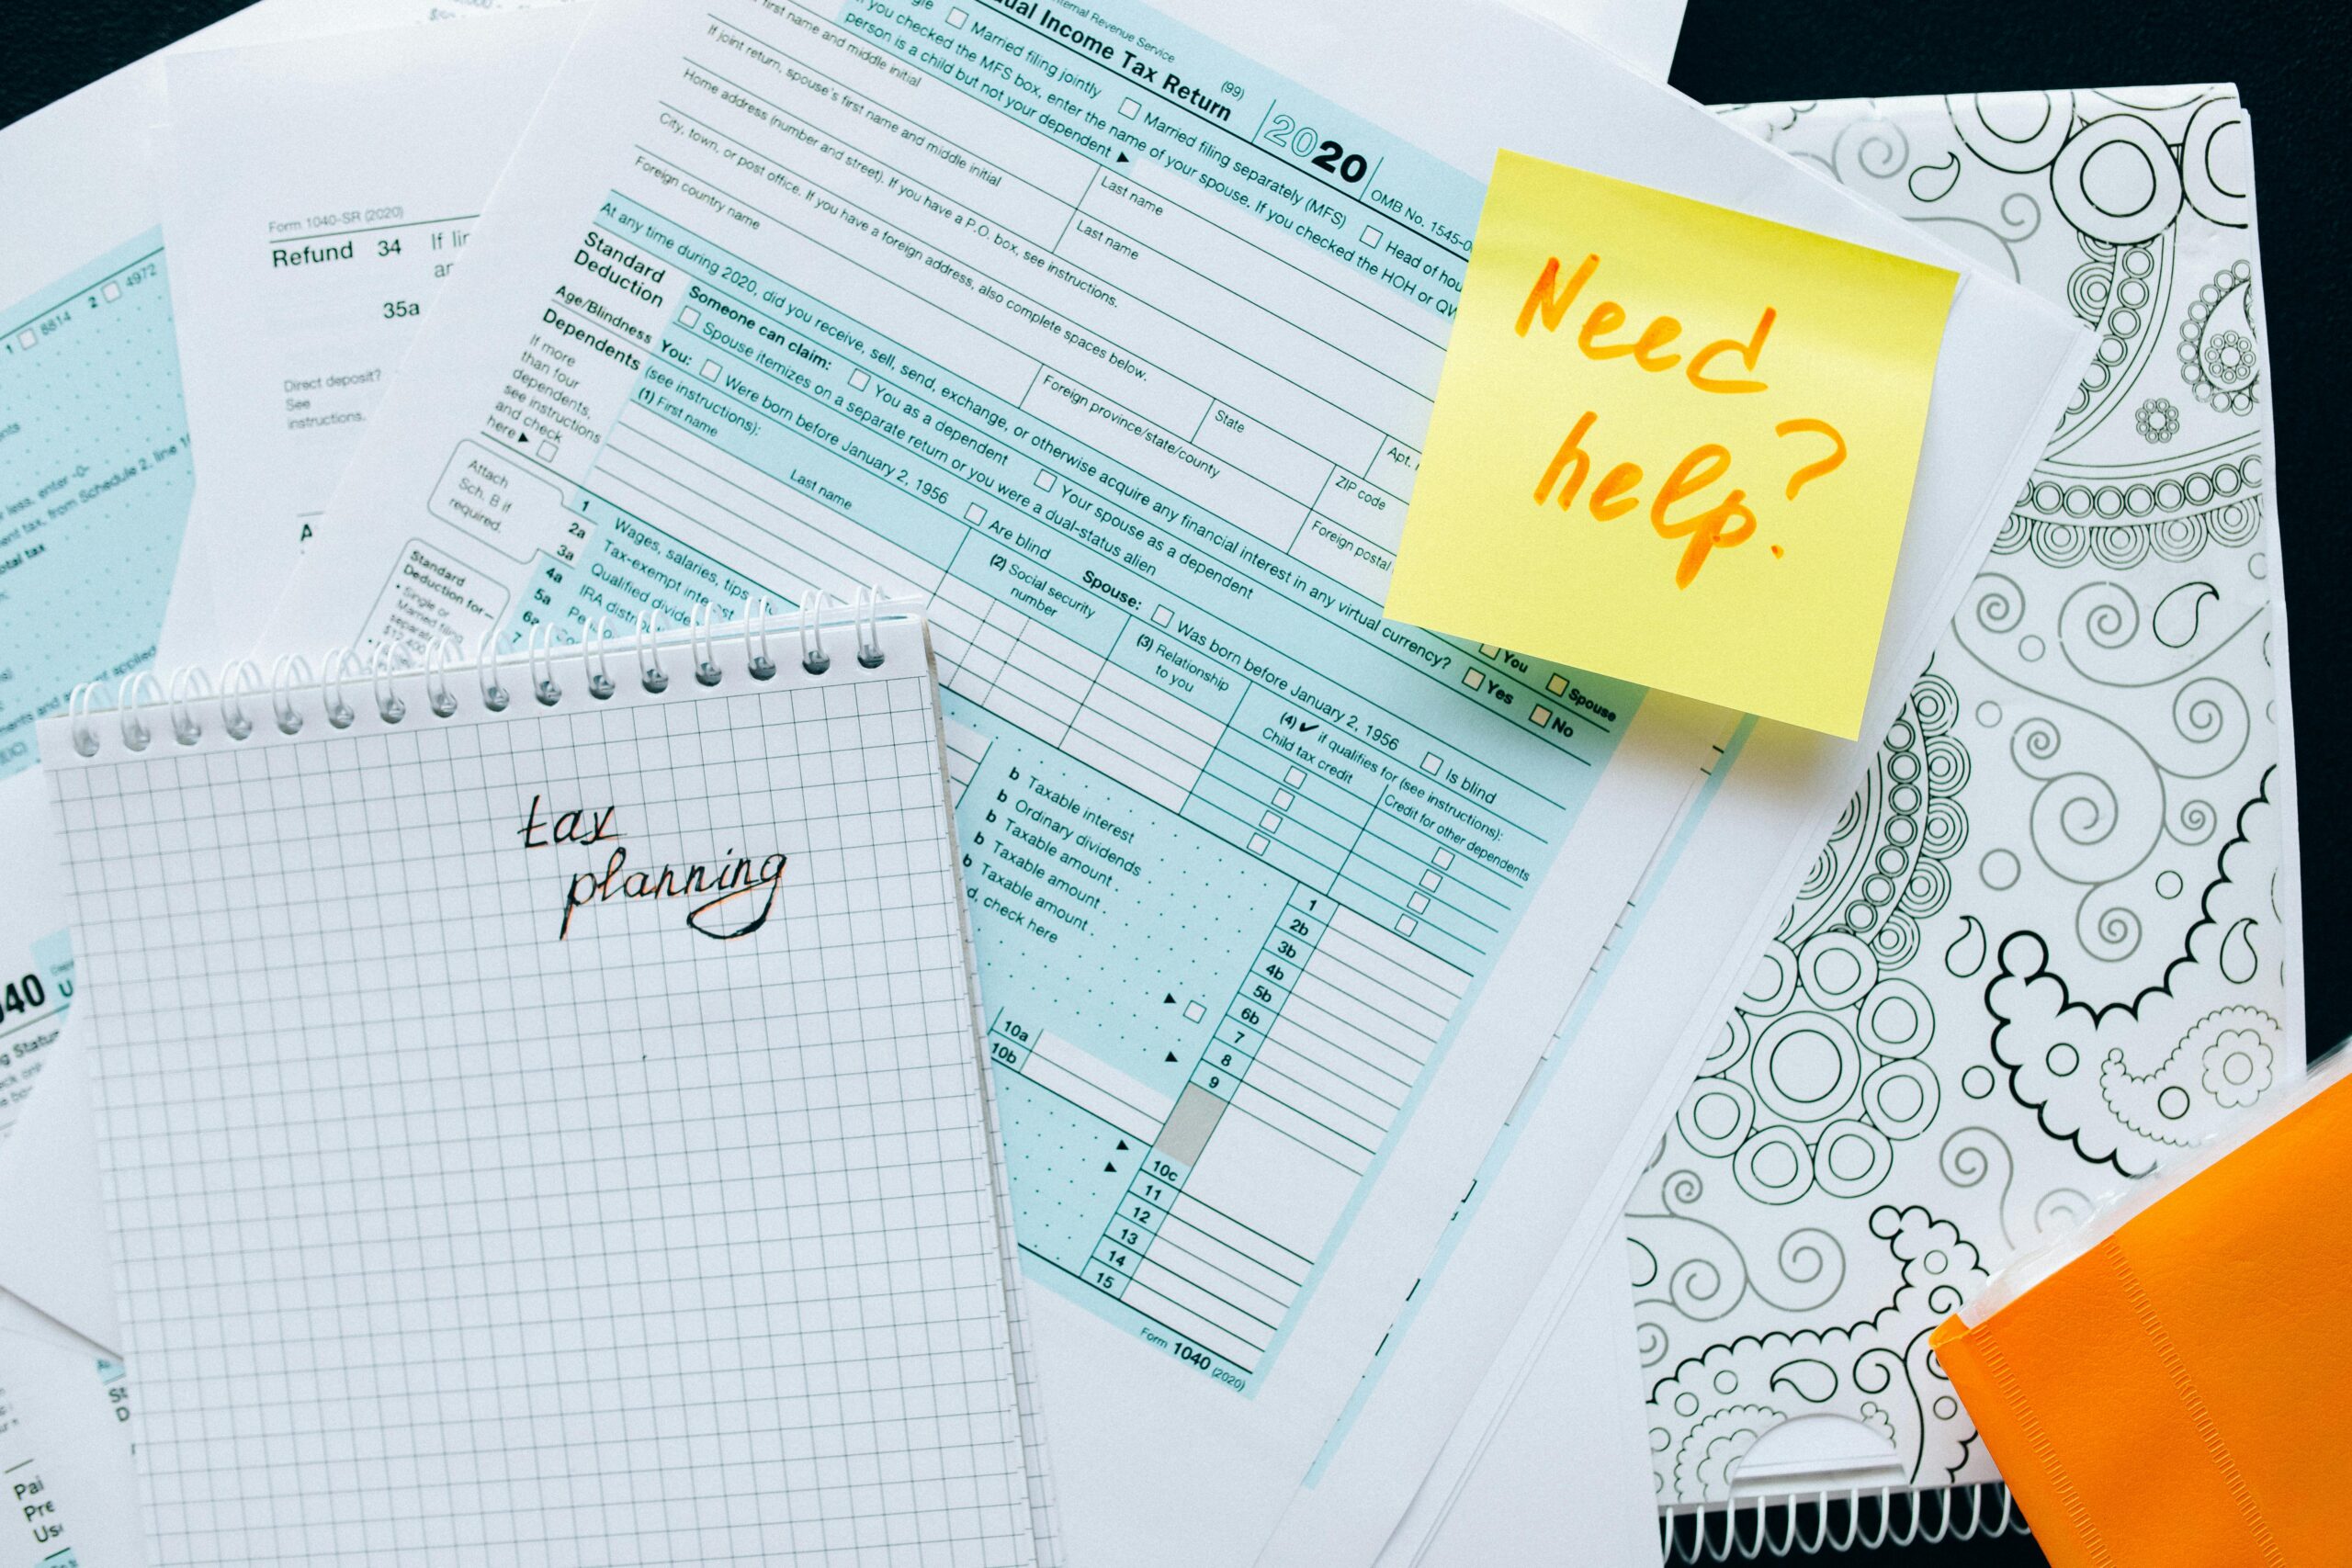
[270,0,2075,1563]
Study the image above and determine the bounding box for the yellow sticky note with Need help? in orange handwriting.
[1385,152,1959,739]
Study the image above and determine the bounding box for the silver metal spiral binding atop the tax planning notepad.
[66,588,885,757]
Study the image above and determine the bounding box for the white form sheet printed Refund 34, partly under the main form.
[158,5,585,668]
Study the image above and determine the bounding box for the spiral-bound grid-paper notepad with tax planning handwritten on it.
[42,611,1040,1565]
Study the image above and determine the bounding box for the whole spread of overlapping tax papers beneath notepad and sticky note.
[0,0,2091,1568]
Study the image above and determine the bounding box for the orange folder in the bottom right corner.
[1931,1063,2352,1568]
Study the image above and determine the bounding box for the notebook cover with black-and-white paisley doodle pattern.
[1628,85,2302,1535]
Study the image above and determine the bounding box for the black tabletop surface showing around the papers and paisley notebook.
[0,0,2352,1568]
